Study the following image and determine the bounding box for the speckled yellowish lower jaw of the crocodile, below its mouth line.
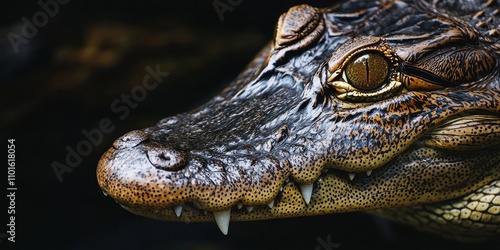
[118,163,500,234]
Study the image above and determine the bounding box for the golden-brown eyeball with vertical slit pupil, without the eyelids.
[345,53,389,90]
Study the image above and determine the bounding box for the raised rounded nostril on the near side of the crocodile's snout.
[147,144,187,171]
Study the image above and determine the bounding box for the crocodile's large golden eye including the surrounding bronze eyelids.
[326,36,402,103]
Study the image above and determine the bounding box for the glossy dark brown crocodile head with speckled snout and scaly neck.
[96,0,500,241]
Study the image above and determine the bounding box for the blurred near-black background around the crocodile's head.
[0,0,491,250]
